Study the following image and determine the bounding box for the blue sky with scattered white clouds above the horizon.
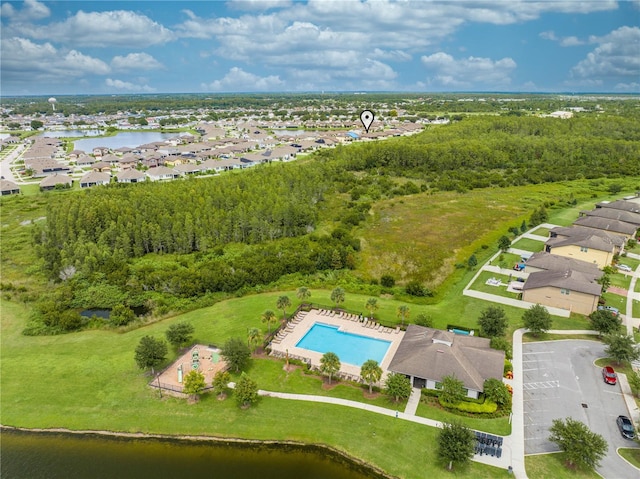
[0,0,640,96]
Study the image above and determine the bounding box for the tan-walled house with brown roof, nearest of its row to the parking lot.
[522,269,602,315]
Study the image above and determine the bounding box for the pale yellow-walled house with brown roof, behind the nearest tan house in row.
[545,235,616,268]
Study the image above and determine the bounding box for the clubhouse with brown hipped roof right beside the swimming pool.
[388,324,505,398]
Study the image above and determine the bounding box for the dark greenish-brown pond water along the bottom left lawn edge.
[0,429,380,479]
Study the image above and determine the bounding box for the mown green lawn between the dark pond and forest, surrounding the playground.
[0,300,506,478]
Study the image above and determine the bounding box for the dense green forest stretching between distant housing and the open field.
[20,116,640,334]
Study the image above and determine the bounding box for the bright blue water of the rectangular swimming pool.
[296,323,391,366]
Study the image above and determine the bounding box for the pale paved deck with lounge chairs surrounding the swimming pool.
[270,309,404,381]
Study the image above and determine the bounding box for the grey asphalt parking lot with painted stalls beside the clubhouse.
[522,340,638,479]
